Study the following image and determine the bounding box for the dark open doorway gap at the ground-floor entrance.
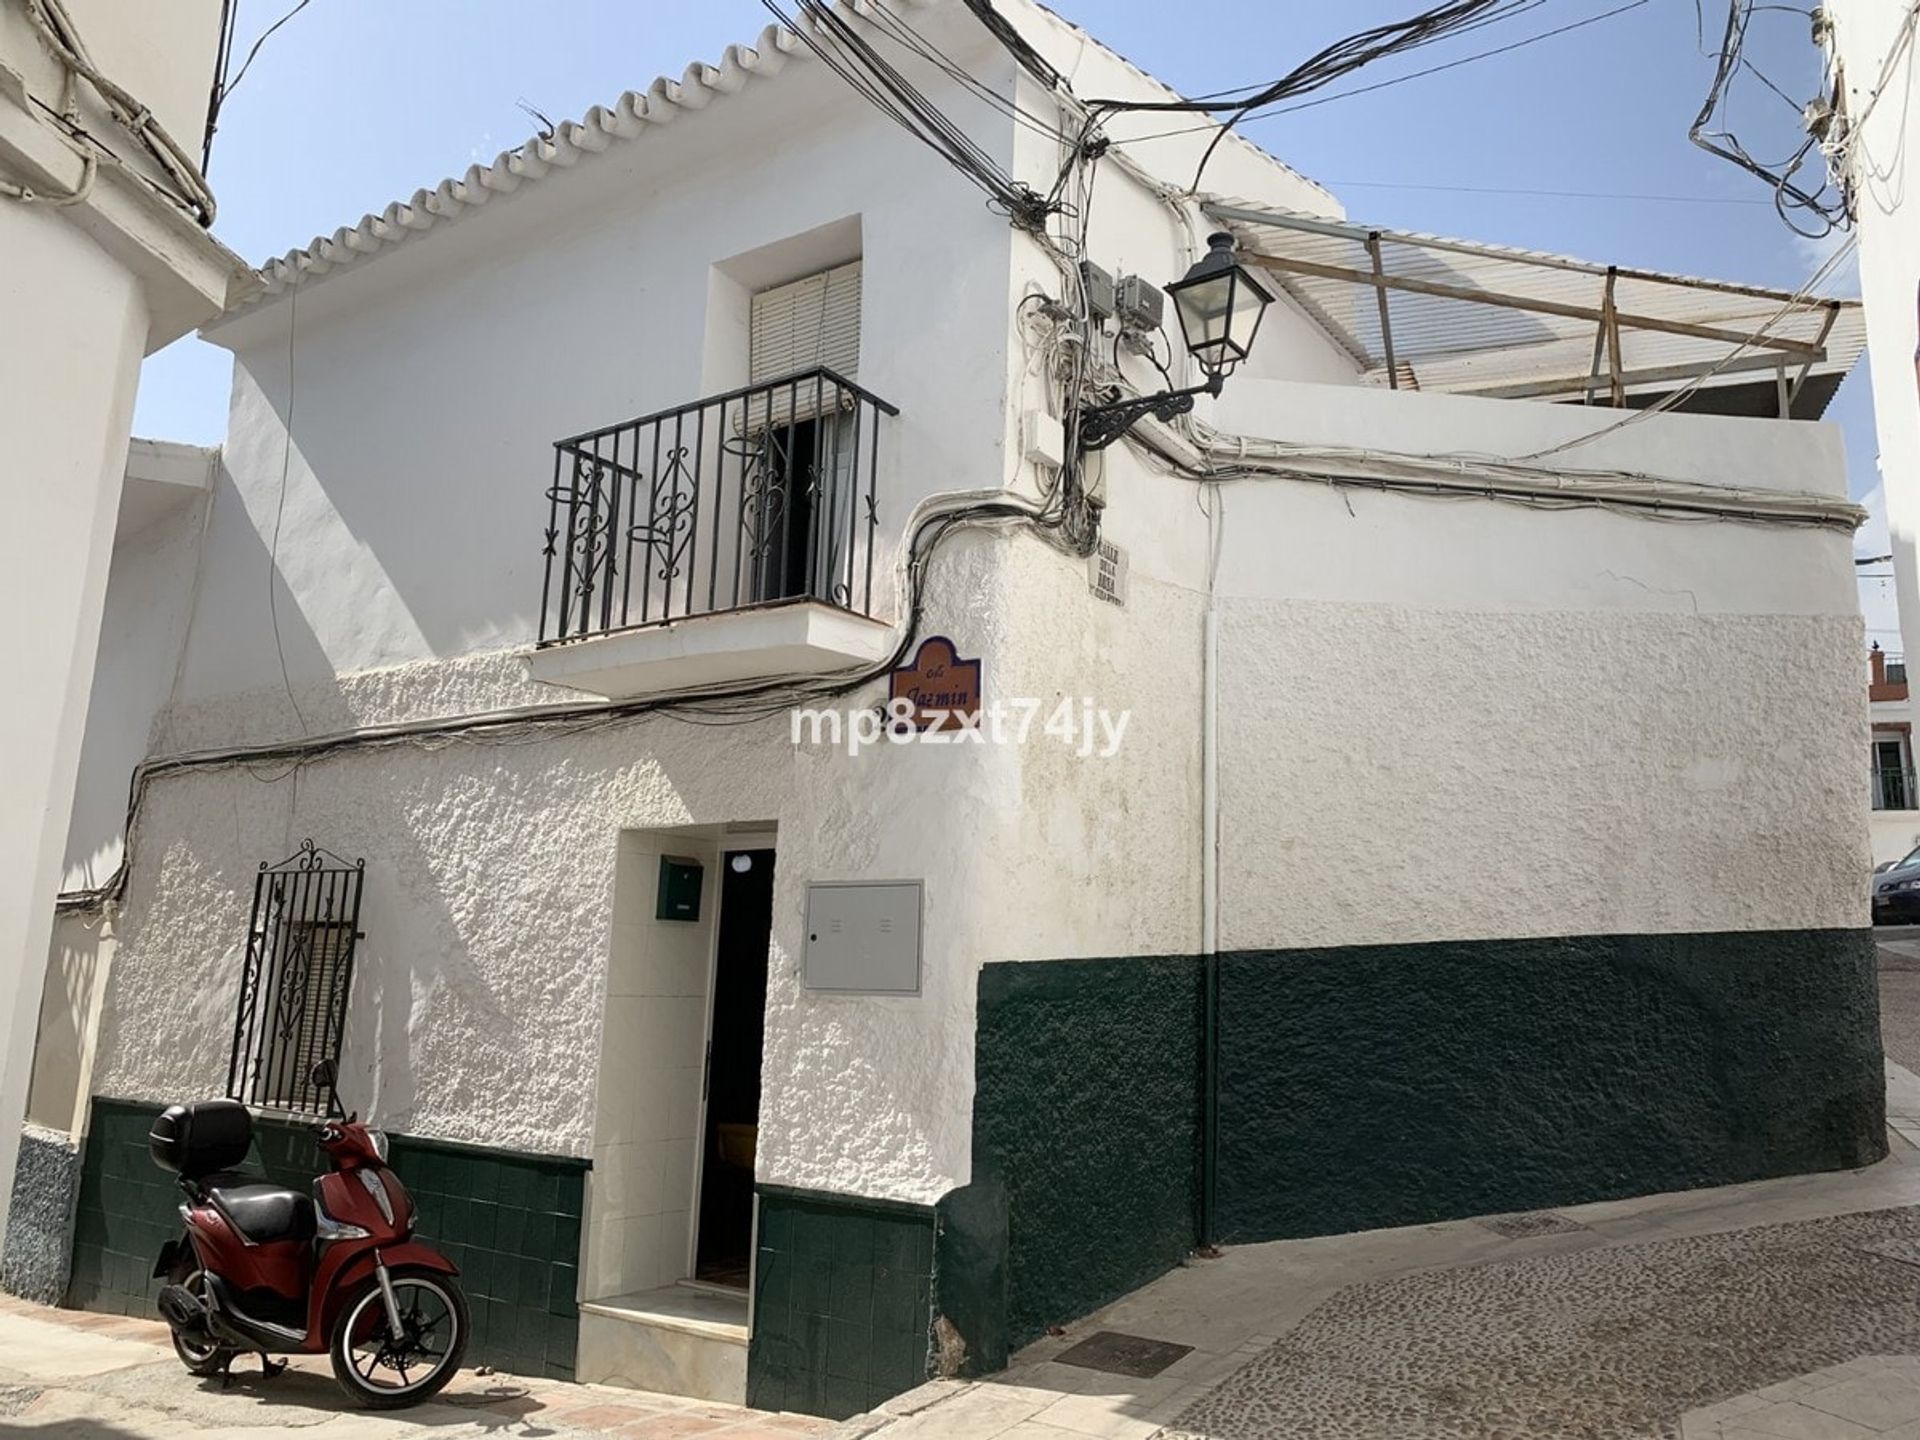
[693,851,774,1288]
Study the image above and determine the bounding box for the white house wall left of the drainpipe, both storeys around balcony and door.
[96,8,1221,1219]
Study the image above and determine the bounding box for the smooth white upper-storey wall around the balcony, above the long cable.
[182,36,1010,721]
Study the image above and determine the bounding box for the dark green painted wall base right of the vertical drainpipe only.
[1217,929,1887,1242]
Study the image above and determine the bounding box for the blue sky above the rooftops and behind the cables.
[145,0,1897,645]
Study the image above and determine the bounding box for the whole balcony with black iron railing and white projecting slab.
[530,369,899,699]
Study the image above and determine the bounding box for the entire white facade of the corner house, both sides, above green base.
[15,2,1868,1397]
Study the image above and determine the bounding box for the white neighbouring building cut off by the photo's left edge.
[0,0,246,1225]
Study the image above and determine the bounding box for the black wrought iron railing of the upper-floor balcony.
[540,369,899,643]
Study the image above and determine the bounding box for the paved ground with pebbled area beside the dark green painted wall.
[837,1066,1920,1440]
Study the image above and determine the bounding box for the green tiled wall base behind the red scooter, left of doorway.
[67,1098,588,1380]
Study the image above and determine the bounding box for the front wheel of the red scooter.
[328,1269,468,1409]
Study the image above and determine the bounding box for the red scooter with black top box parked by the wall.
[148,1062,468,1409]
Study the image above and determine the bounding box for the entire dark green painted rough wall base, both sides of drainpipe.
[967,929,1885,1369]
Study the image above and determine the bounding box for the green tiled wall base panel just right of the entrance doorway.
[747,1187,935,1419]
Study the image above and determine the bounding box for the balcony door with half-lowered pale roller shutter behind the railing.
[741,261,860,605]
